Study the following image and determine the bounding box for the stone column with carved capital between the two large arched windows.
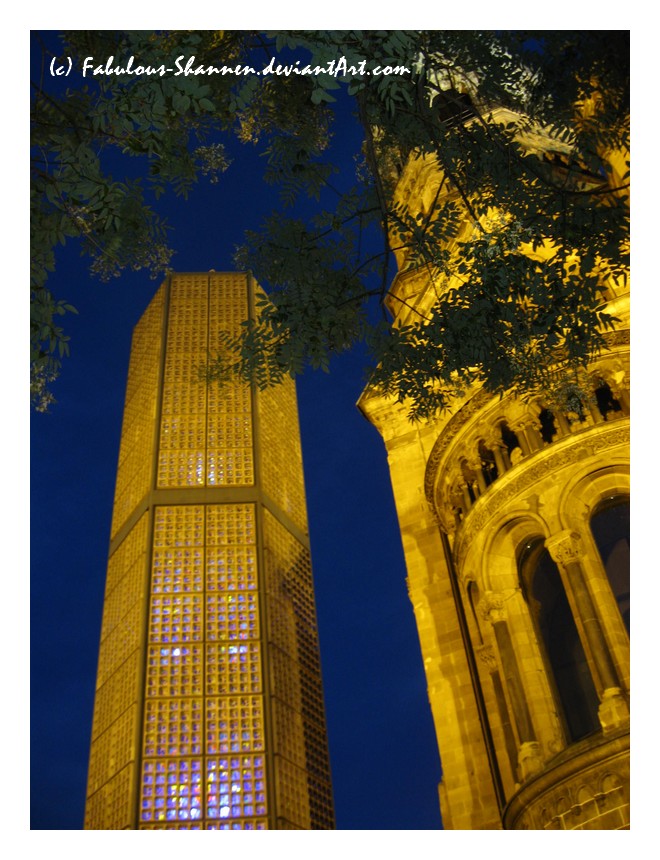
[545,529,630,731]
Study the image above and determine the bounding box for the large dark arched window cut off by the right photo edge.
[591,496,630,635]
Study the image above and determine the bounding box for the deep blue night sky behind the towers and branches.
[31,30,441,830]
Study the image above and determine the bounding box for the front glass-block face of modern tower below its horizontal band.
[140,504,266,829]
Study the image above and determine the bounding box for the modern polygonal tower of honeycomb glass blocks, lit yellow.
[85,272,334,830]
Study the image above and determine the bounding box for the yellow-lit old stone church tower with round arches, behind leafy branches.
[359,112,630,830]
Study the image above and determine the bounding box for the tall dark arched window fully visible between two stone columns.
[519,538,600,742]
